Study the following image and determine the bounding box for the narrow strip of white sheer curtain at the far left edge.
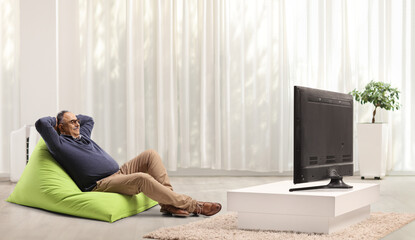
[0,0,21,177]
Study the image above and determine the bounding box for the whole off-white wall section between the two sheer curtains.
[20,0,82,126]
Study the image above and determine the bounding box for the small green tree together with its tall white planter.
[350,81,400,179]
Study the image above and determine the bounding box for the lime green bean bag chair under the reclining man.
[7,139,157,222]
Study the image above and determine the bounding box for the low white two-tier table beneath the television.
[227,181,380,233]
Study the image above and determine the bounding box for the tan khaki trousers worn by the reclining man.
[92,150,197,212]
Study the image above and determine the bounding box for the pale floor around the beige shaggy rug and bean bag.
[0,176,415,240]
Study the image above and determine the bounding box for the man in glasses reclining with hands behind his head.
[35,111,222,216]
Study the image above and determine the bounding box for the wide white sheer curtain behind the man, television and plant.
[79,0,415,172]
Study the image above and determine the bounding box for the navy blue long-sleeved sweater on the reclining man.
[35,115,119,191]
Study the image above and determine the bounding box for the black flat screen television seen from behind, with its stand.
[290,86,353,191]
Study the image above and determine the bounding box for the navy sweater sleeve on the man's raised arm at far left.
[35,117,60,152]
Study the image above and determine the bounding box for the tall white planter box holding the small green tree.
[357,123,388,179]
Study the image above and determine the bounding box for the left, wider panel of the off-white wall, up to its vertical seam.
[19,0,57,126]
